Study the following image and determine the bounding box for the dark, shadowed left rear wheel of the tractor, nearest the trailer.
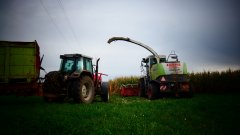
[42,71,64,102]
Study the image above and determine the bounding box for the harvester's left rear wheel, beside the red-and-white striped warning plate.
[147,83,160,100]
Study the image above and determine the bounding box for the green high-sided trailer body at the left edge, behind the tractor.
[0,41,40,95]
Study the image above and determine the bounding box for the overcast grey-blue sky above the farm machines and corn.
[0,0,240,79]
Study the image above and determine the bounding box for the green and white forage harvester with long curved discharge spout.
[108,37,192,99]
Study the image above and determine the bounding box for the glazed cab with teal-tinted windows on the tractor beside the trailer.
[60,54,93,74]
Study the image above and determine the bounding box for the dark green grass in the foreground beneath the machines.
[0,94,240,135]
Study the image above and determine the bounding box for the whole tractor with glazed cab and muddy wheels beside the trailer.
[42,54,109,104]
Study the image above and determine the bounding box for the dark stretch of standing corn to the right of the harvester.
[190,69,240,93]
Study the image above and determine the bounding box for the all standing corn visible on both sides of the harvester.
[109,69,240,94]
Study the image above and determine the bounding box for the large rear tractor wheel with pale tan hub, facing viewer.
[73,76,95,104]
